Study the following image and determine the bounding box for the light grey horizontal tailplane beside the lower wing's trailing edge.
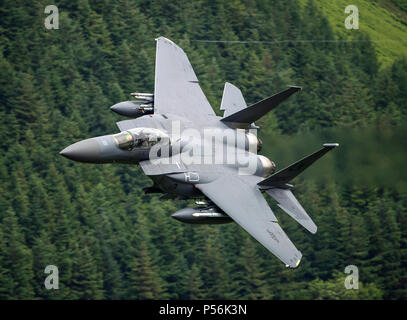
[266,188,317,233]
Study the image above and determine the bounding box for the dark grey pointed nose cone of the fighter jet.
[59,138,100,162]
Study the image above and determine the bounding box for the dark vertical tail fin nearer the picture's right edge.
[258,143,339,189]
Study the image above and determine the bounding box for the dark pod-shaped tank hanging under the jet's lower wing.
[171,207,233,224]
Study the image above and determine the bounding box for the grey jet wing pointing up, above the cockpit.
[154,37,215,120]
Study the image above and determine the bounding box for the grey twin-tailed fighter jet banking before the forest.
[60,37,338,268]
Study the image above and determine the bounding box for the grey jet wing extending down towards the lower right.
[196,172,302,268]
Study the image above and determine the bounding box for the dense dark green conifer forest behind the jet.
[0,0,407,299]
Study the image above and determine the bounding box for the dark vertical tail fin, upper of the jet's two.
[221,87,301,125]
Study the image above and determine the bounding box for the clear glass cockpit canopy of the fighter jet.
[113,128,170,150]
